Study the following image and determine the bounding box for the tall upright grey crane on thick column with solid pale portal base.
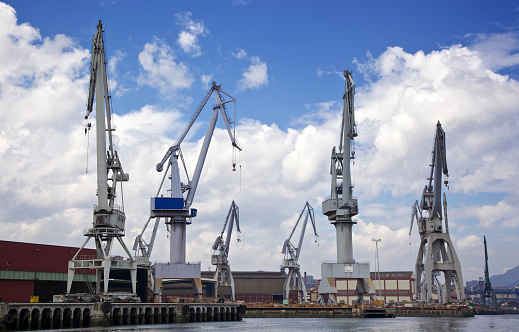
[319,70,375,303]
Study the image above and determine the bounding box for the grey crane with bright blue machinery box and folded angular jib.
[134,82,241,297]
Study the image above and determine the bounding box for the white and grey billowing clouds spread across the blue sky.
[0,3,519,280]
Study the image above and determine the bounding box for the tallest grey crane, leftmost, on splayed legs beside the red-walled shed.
[67,20,137,300]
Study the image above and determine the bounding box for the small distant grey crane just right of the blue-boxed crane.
[211,201,241,301]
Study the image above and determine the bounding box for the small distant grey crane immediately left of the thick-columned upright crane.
[281,202,319,303]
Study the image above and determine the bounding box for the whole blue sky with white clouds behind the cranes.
[0,0,519,281]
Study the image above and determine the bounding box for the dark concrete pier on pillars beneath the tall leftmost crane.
[0,302,245,331]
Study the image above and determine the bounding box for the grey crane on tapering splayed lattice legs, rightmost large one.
[409,121,466,304]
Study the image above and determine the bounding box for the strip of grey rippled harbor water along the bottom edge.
[49,315,519,332]
